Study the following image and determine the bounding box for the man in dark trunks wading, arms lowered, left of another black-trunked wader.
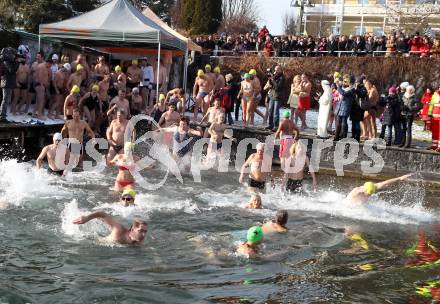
[239,143,272,193]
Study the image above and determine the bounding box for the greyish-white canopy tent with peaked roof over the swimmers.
[39,0,192,96]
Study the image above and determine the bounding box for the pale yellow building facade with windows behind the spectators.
[292,0,440,36]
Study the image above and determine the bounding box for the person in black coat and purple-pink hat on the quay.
[379,86,401,146]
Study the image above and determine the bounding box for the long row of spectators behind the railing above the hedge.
[196,27,440,58]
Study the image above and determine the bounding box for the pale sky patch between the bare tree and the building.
[254,0,294,35]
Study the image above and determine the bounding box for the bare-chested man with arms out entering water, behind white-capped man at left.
[61,108,95,167]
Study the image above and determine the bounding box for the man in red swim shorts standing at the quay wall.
[275,110,299,170]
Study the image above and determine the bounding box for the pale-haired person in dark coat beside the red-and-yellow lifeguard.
[399,85,421,148]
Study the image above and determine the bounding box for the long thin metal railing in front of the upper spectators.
[211,50,431,58]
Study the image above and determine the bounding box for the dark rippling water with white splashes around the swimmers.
[0,160,440,303]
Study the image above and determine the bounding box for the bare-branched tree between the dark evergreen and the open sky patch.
[220,0,259,33]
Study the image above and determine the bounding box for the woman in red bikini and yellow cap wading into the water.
[107,142,136,191]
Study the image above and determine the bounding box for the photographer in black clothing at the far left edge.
[0,47,18,123]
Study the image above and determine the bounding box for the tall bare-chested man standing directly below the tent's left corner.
[34,58,52,119]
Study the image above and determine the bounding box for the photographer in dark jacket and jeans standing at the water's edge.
[264,65,285,131]
